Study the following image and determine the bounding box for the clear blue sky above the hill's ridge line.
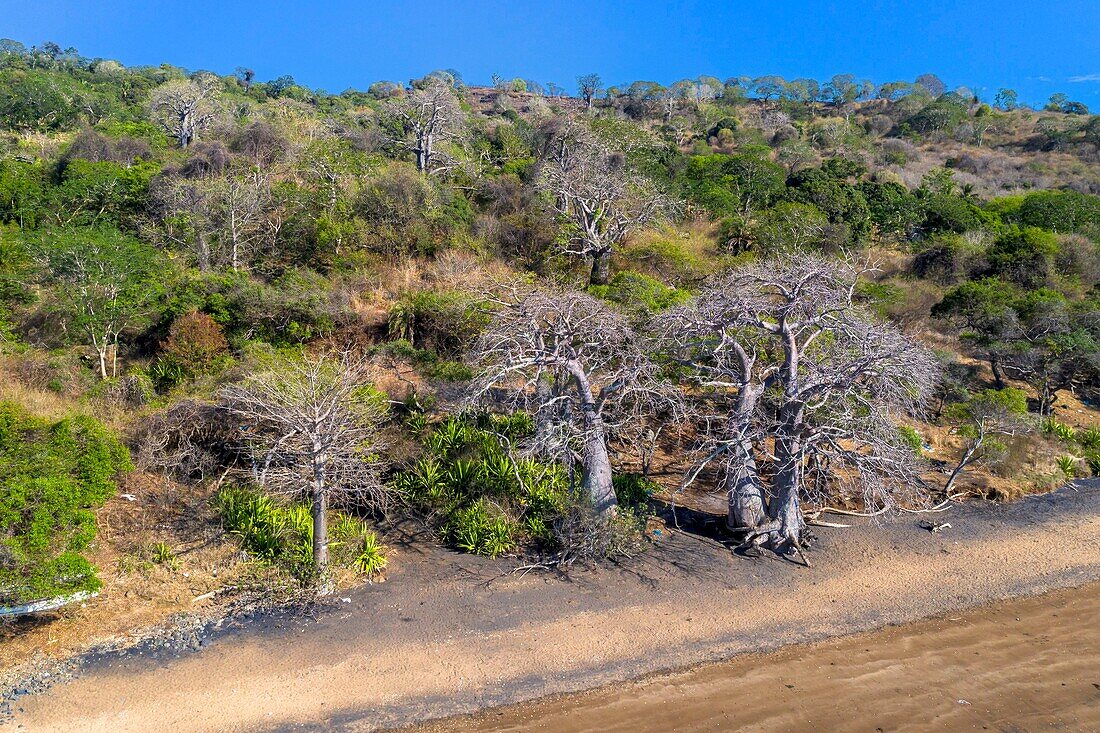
[0,0,1100,109]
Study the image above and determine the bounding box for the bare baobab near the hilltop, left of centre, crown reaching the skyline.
[382,75,463,174]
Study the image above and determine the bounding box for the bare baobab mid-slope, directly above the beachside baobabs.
[538,120,673,285]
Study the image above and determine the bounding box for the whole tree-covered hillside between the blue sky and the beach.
[0,41,1100,638]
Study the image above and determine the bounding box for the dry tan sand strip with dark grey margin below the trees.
[0,482,1100,731]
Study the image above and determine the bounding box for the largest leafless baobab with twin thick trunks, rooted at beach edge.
[660,253,937,551]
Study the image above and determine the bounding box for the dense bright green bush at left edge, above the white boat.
[0,403,133,604]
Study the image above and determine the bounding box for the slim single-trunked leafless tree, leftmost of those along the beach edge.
[220,352,387,577]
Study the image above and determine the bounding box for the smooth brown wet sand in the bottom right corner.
[414,583,1100,733]
